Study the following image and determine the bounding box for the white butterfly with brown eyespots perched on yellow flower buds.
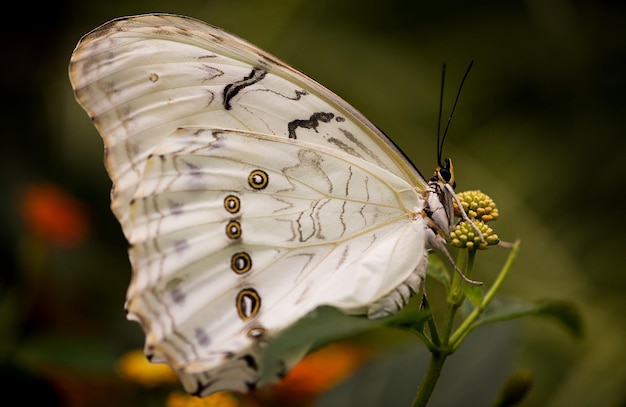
[69,14,478,395]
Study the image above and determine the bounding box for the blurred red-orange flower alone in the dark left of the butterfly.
[20,184,89,248]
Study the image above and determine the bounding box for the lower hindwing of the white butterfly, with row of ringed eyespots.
[127,128,425,394]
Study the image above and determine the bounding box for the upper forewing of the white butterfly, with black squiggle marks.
[70,14,426,228]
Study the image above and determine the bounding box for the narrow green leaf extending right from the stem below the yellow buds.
[472,297,583,336]
